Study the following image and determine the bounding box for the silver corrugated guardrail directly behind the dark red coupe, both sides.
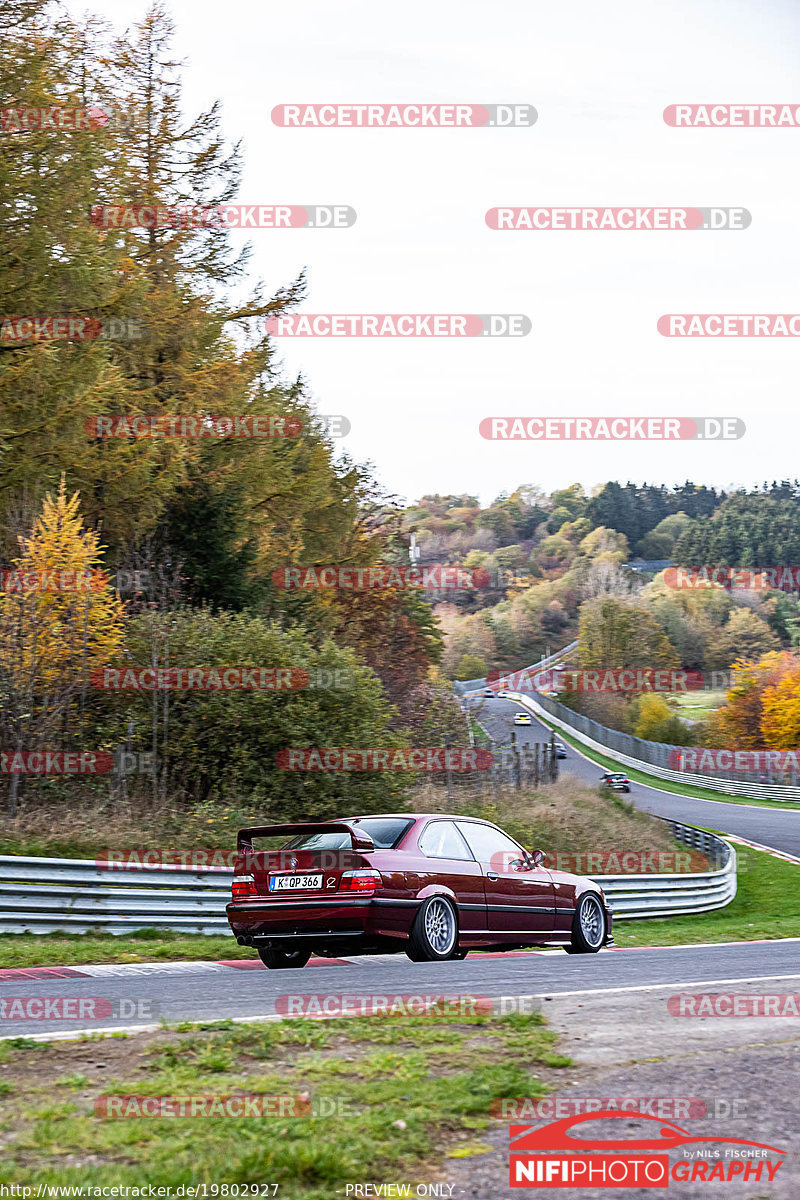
[0,821,736,935]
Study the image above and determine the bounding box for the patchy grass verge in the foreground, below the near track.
[0,1006,571,1200]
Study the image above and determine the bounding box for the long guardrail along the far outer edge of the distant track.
[509,691,800,803]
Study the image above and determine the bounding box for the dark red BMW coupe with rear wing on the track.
[227,814,612,967]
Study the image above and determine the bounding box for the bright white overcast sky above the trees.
[74,0,800,502]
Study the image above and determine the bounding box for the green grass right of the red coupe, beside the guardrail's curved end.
[614,830,800,947]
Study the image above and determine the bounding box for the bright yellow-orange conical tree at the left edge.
[0,475,125,696]
